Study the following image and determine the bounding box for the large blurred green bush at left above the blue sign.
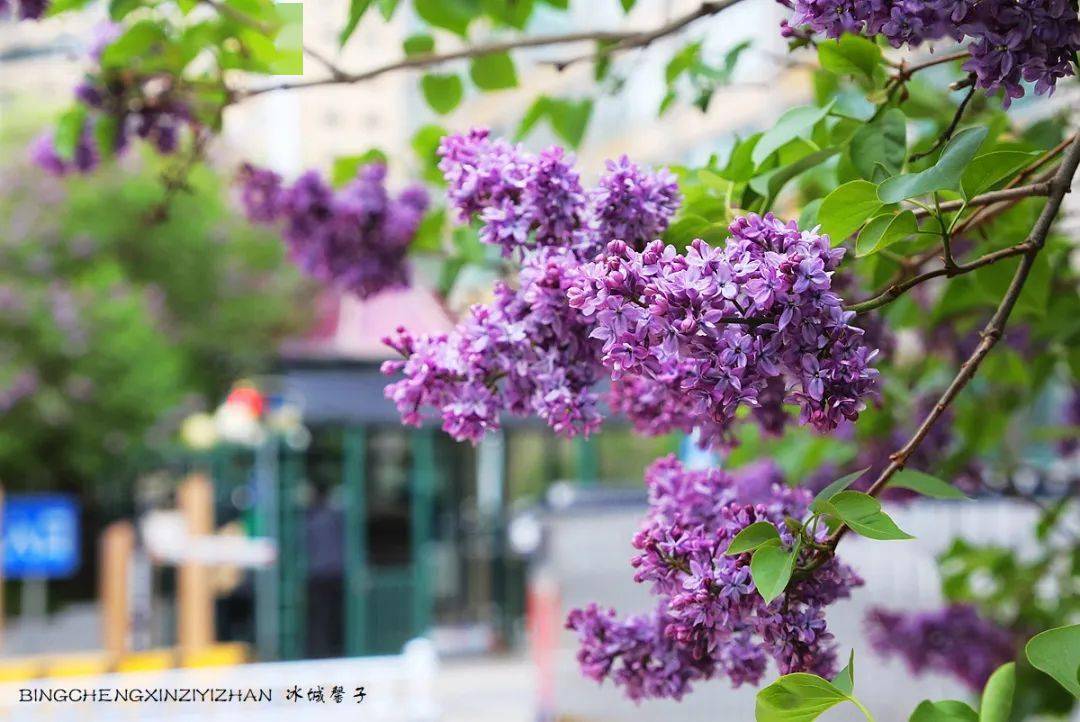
[0,142,309,489]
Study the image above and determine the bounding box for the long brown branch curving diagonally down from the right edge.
[829,132,1080,553]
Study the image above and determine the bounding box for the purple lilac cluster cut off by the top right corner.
[781,0,1080,107]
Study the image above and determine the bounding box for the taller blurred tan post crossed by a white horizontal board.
[176,474,214,652]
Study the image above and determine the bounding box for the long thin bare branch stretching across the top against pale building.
[233,0,742,100]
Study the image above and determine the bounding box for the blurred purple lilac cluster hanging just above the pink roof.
[240,163,428,298]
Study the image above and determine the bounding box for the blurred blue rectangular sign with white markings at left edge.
[0,494,80,580]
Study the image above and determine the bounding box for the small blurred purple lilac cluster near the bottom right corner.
[867,604,1018,691]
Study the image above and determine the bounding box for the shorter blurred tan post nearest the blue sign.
[98,521,135,657]
